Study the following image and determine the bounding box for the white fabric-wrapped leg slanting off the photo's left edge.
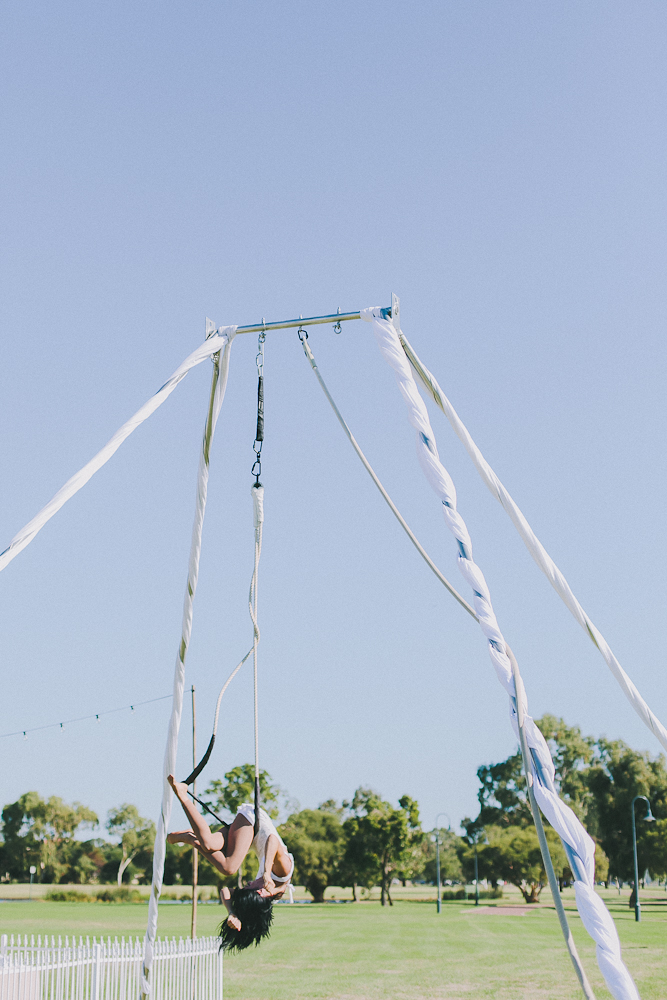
[0,326,236,571]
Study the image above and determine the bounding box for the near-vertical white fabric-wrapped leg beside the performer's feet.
[141,321,236,997]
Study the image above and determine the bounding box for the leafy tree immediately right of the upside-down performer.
[279,801,345,903]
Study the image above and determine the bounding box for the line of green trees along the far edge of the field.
[0,715,667,905]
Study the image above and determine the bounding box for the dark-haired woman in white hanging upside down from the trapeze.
[167,774,294,951]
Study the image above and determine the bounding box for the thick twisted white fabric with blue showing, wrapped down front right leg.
[361,307,639,1000]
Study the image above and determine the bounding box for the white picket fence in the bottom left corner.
[0,934,222,1000]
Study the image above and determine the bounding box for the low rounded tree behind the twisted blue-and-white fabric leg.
[474,826,567,903]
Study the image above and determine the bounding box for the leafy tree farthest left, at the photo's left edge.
[2,792,97,882]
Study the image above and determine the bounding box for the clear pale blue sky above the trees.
[0,2,667,840]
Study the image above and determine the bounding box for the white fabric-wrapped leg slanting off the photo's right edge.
[400,333,667,750]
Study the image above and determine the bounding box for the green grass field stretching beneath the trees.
[0,889,667,1000]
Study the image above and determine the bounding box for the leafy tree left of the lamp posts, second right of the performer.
[341,788,422,906]
